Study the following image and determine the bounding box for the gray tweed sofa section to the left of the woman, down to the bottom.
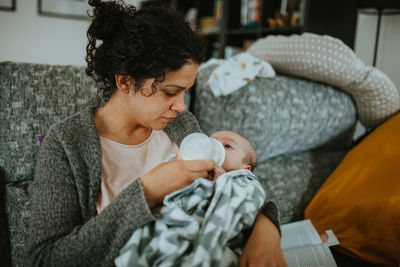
[0,62,99,266]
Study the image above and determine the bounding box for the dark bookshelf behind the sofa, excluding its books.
[169,0,357,58]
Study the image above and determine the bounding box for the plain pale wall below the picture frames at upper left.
[0,0,89,65]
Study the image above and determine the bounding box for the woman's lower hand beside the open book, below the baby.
[239,214,287,267]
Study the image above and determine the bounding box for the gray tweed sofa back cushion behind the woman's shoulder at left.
[0,62,99,182]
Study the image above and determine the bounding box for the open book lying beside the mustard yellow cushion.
[281,220,339,267]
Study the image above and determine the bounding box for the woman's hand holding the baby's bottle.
[140,158,215,208]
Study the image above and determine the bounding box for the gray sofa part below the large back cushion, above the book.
[254,149,347,223]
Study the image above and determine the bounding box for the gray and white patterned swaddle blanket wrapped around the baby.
[115,169,266,267]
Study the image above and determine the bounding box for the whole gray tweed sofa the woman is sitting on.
[0,34,396,266]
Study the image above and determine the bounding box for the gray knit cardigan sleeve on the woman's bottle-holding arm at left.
[28,131,154,266]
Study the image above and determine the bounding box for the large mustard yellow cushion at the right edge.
[305,114,400,265]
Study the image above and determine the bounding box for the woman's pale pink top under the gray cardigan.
[96,130,177,213]
